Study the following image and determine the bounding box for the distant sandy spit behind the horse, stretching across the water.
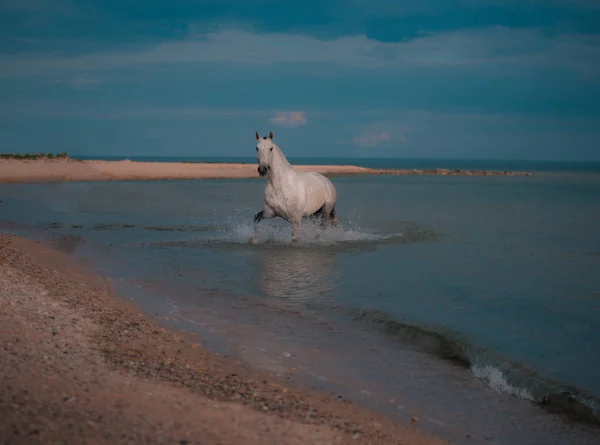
[0,158,532,183]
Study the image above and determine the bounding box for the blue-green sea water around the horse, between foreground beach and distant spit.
[0,174,600,444]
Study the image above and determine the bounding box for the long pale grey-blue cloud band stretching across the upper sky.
[0,27,600,78]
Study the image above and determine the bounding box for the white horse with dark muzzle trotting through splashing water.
[251,131,337,242]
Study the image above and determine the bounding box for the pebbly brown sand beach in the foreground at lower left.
[0,234,448,445]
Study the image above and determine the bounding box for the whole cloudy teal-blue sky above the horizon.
[0,0,600,161]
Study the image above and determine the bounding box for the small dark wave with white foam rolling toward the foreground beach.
[351,309,600,424]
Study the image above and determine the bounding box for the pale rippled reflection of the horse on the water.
[259,248,339,303]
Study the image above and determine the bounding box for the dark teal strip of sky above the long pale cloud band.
[0,0,600,50]
